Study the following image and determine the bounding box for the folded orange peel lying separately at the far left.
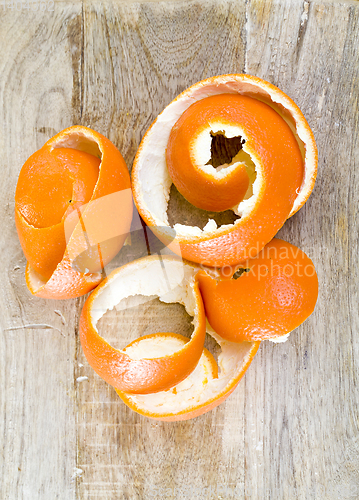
[15,126,133,299]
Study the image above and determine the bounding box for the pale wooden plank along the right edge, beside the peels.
[246,1,359,499]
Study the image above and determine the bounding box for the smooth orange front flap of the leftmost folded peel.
[15,148,100,279]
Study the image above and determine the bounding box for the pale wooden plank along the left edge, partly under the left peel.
[0,4,81,500]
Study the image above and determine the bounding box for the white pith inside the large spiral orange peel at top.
[136,75,316,239]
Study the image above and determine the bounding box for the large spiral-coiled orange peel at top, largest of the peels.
[132,74,317,267]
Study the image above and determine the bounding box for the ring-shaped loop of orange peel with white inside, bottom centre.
[80,256,206,394]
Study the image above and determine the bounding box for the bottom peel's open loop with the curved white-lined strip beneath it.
[80,256,259,421]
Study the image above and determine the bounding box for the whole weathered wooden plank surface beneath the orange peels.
[0,0,359,500]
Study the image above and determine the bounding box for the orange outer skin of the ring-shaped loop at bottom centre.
[80,256,206,394]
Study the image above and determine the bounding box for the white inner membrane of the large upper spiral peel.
[137,75,315,237]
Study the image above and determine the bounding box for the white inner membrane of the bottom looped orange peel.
[91,257,253,414]
